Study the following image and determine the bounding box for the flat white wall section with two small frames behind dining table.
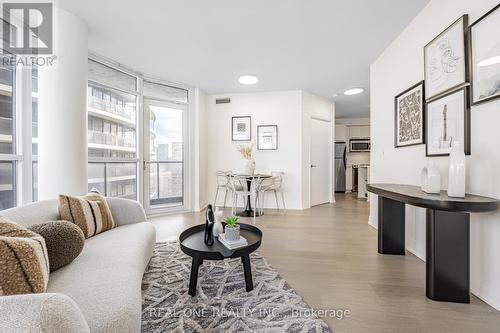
[206,91,302,209]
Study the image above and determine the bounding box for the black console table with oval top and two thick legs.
[367,184,500,303]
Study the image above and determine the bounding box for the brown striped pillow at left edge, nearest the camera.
[0,217,50,296]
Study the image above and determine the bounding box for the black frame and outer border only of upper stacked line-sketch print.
[424,14,470,102]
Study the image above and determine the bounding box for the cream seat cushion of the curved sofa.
[47,222,156,332]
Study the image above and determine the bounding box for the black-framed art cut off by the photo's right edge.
[470,4,500,105]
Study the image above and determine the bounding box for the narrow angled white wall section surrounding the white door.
[301,91,335,205]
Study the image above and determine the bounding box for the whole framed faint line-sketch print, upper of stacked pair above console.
[424,15,469,101]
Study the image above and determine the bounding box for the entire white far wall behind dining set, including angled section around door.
[206,91,335,209]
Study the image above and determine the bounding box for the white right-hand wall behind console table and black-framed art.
[370,0,500,310]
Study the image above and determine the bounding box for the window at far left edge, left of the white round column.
[0,60,38,210]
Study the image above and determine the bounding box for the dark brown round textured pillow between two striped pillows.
[29,221,85,272]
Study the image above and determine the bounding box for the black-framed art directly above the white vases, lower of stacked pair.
[425,87,470,156]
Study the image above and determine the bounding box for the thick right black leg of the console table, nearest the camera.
[426,209,470,303]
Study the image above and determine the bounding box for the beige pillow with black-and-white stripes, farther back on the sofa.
[59,193,116,238]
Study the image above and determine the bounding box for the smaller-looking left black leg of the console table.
[378,196,405,255]
